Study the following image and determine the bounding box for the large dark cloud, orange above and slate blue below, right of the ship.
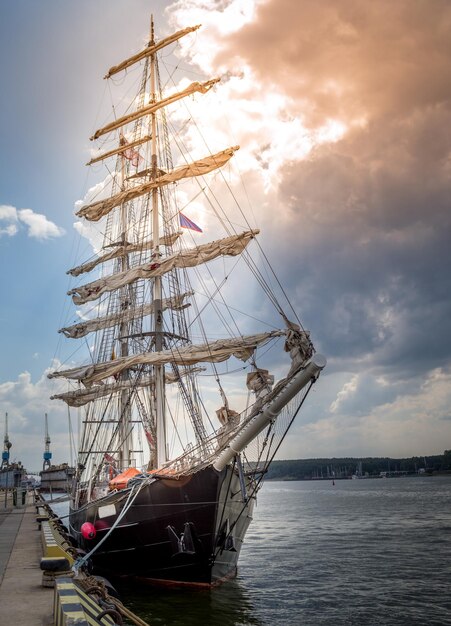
[220,0,451,377]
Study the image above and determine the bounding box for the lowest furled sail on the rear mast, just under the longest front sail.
[50,367,205,407]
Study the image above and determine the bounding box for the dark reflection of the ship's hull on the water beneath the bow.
[116,579,263,626]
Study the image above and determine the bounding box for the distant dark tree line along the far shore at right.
[265,450,451,480]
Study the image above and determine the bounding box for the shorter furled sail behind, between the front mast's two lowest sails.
[58,291,193,339]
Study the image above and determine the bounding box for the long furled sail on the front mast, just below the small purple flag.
[67,230,260,305]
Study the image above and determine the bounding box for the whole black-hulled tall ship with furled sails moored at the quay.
[49,20,326,586]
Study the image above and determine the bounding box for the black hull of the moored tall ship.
[70,467,255,586]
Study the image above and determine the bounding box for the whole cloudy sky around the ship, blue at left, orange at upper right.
[0,0,451,469]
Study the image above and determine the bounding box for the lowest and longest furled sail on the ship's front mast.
[48,330,285,387]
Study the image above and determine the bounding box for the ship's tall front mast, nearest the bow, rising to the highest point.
[150,15,167,467]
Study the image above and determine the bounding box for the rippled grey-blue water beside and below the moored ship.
[49,476,451,626]
